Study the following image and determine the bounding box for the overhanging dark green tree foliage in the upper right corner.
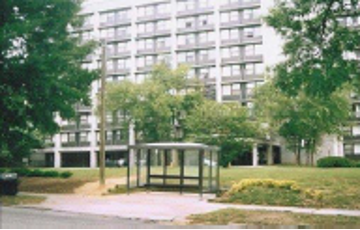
[266,0,360,98]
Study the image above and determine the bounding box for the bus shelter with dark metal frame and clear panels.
[127,143,221,196]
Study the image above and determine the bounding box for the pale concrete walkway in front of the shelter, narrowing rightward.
[23,193,360,222]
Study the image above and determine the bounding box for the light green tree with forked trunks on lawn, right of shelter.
[255,82,351,165]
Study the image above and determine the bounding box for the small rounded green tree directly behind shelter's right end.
[185,100,258,167]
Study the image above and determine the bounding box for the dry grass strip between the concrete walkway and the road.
[188,209,360,229]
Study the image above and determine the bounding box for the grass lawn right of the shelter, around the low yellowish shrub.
[221,167,360,209]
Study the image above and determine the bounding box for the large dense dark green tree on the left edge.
[0,0,96,165]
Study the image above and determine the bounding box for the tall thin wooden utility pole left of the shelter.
[99,40,107,186]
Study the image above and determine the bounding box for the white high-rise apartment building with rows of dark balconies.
[32,0,354,167]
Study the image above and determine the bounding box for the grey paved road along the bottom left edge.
[0,208,239,229]
